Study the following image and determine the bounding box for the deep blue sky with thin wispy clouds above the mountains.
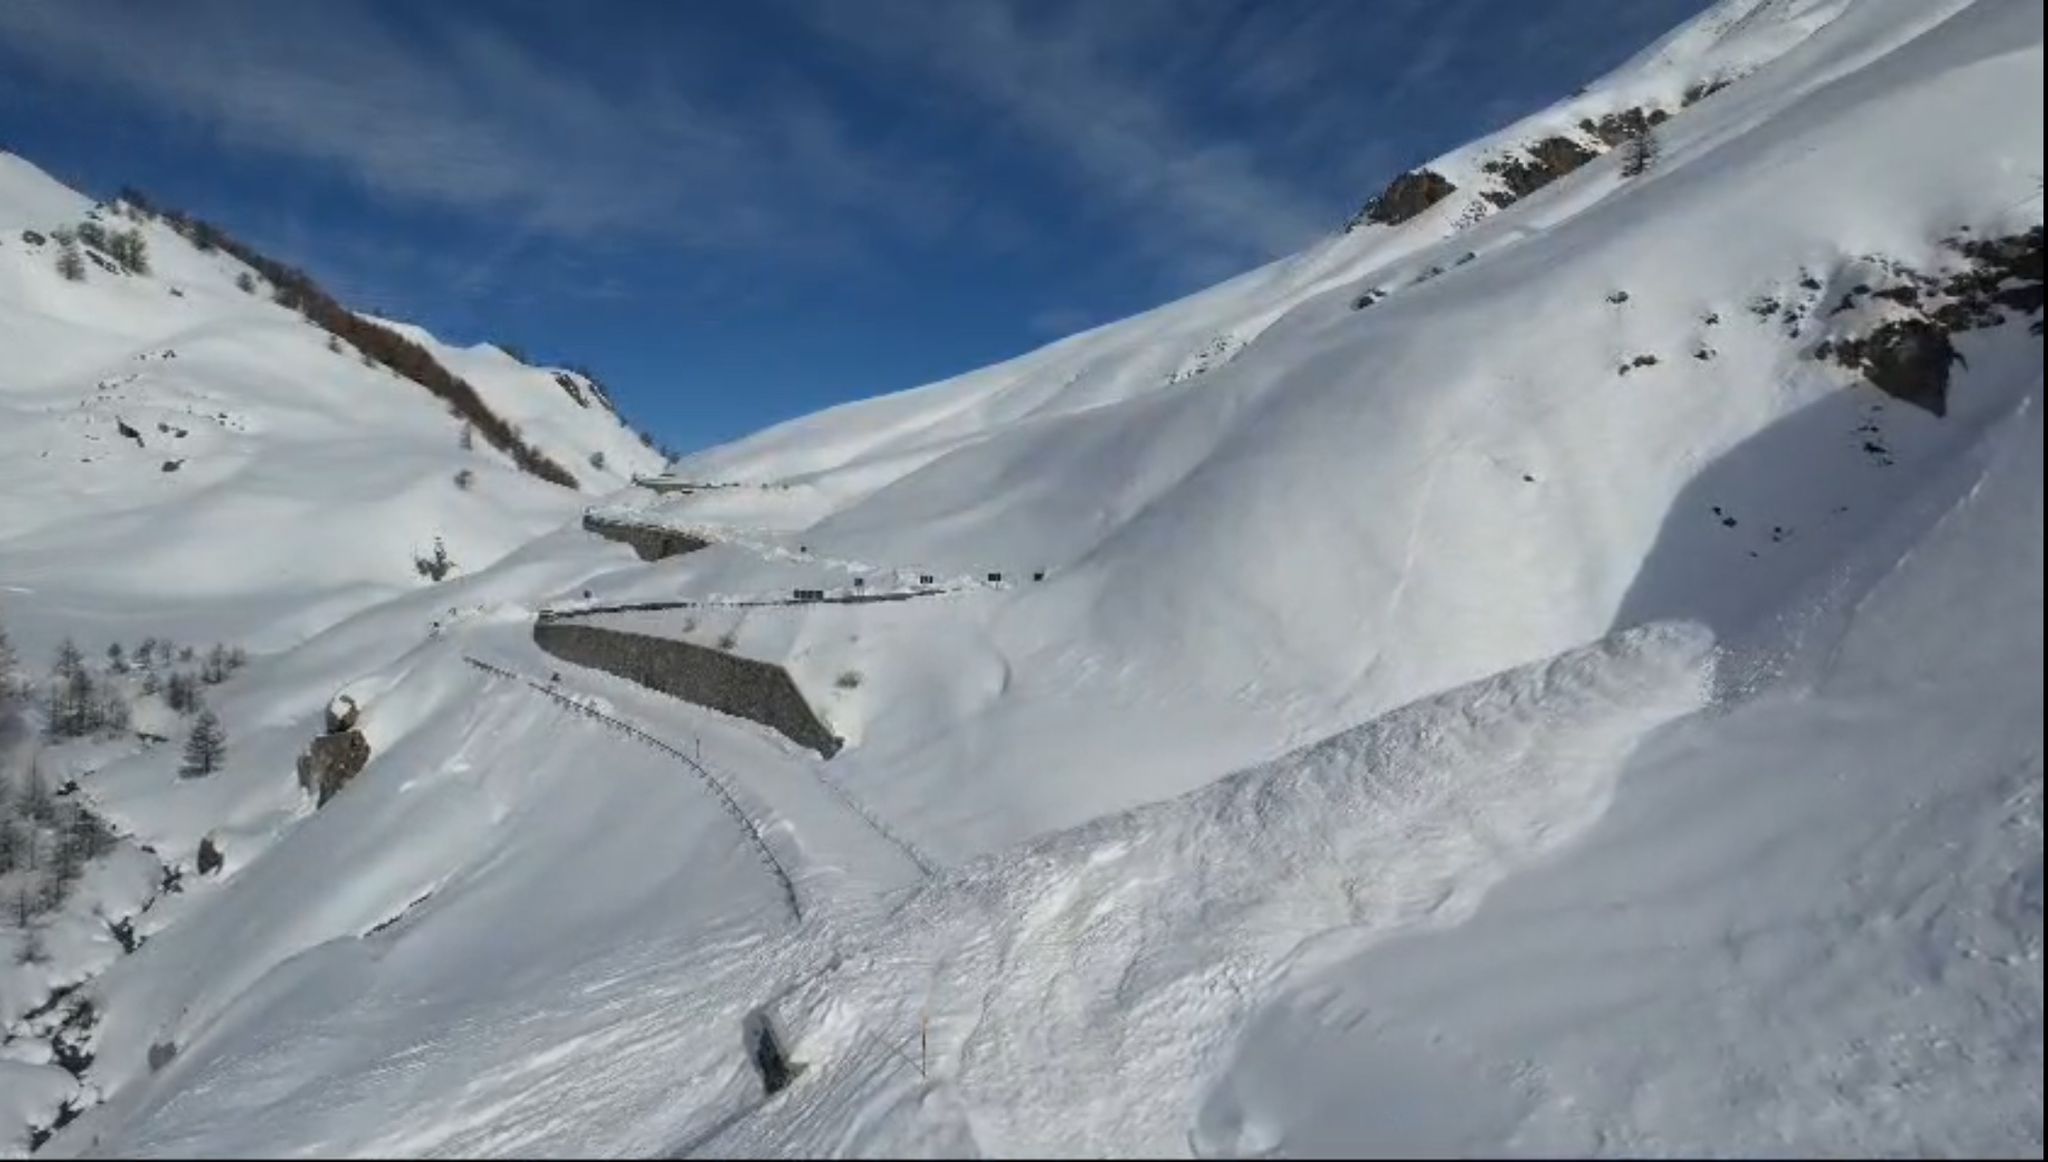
[0,0,1704,449]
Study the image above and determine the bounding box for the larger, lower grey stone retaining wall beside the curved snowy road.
[532,619,844,758]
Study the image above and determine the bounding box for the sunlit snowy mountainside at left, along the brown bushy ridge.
[0,154,657,656]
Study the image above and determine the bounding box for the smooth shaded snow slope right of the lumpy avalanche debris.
[1198,393,2042,1158]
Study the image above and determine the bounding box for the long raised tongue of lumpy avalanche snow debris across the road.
[702,625,1712,1156]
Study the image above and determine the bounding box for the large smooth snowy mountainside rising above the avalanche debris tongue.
[557,2,2042,859]
